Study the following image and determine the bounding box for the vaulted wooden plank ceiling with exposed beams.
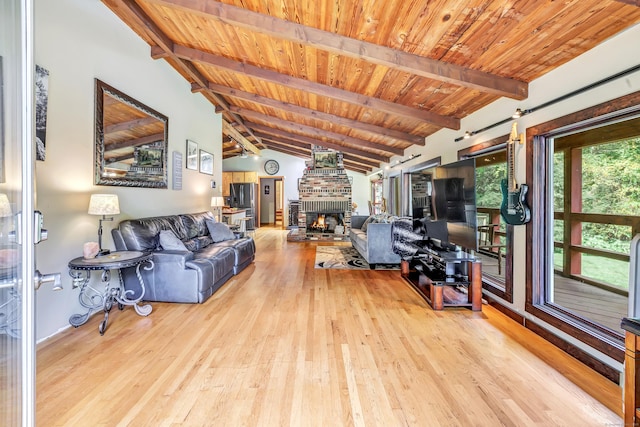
[102,0,640,173]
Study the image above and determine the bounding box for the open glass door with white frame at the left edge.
[0,0,35,427]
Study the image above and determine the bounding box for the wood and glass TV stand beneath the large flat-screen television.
[401,247,482,311]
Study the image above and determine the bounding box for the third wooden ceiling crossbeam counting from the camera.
[209,83,424,145]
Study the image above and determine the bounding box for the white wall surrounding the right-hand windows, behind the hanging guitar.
[378,25,640,370]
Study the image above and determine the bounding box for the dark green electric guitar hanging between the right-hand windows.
[500,123,531,225]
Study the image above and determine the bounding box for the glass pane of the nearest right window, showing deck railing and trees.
[544,122,640,334]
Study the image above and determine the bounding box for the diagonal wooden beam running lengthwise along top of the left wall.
[115,0,260,143]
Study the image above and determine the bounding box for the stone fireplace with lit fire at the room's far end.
[290,152,351,240]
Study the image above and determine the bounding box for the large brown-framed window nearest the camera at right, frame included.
[526,93,640,361]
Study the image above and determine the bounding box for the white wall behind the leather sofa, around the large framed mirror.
[35,0,222,339]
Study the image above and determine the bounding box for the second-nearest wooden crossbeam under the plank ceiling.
[173,44,460,130]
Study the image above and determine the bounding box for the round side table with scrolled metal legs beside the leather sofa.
[69,251,154,335]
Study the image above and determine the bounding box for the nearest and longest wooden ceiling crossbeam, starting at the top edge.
[148,0,528,100]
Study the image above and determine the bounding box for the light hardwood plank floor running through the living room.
[37,228,622,427]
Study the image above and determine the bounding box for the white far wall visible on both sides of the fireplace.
[222,150,370,222]
